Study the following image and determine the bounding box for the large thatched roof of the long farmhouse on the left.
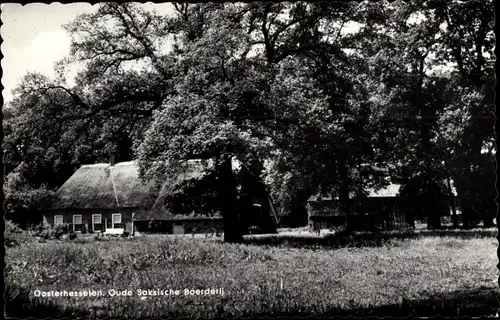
[46,160,239,221]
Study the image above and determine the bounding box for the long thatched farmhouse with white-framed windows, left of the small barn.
[43,160,277,234]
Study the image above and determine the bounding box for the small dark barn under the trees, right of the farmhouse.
[307,184,409,231]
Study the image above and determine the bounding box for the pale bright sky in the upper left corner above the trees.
[0,2,171,102]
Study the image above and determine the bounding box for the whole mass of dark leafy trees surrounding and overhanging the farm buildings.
[3,0,496,241]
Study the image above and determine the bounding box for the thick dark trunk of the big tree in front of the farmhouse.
[219,156,243,243]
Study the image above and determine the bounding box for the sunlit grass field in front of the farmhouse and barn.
[5,232,498,318]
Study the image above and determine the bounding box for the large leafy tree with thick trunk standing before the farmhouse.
[136,3,372,241]
